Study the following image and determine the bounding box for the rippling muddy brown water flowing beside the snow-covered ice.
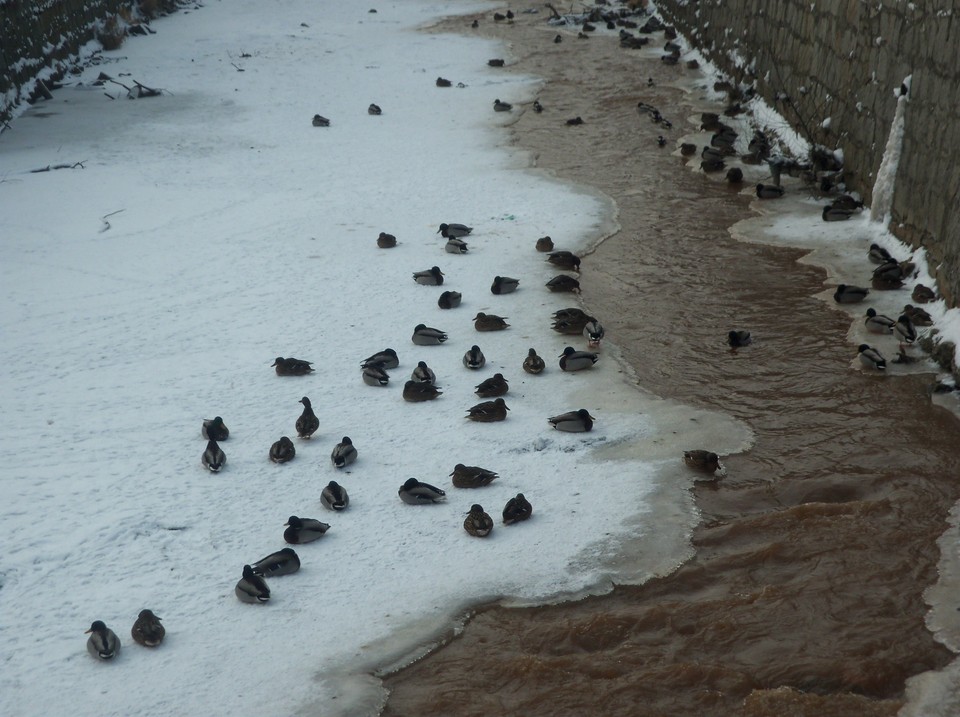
[383,13,960,717]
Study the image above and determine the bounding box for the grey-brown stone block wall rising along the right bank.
[658,0,960,306]
